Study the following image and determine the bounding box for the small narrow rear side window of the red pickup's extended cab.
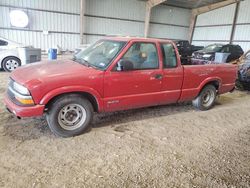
[161,43,177,68]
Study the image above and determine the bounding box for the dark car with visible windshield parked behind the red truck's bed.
[192,44,244,63]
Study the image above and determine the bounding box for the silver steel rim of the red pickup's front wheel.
[58,104,87,131]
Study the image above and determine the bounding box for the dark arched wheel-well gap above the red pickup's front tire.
[45,92,98,112]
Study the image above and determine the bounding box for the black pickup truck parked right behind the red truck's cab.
[175,40,204,58]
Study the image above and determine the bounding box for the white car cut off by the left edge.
[0,37,23,72]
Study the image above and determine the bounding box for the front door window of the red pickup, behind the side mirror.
[122,42,159,70]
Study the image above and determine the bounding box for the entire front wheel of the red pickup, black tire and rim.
[46,94,94,137]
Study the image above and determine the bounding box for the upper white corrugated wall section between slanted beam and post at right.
[196,4,236,26]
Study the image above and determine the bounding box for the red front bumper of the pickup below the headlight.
[4,95,45,117]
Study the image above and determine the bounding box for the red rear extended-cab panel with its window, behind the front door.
[161,43,183,104]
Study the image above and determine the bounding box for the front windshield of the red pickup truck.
[74,40,125,70]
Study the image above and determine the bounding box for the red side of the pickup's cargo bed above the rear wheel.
[180,64,237,101]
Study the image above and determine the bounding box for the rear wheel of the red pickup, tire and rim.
[192,85,217,111]
